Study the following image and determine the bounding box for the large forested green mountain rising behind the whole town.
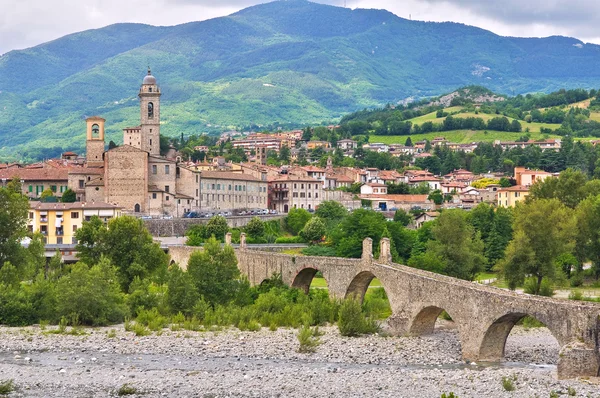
[0,0,600,160]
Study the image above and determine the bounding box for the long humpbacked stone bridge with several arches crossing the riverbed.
[170,235,600,378]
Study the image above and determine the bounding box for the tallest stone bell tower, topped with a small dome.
[138,68,160,156]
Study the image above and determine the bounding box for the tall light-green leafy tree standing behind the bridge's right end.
[499,199,576,294]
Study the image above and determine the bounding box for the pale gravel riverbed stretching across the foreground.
[0,321,600,398]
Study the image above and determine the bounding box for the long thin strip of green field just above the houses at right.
[369,130,564,145]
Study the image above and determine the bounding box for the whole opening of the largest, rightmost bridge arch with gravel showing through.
[479,312,560,364]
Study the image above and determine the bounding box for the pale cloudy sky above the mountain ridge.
[0,0,600,54]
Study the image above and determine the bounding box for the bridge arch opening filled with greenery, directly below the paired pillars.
[345,271,392,320]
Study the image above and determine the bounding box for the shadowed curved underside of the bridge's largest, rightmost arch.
[479,312,566,361]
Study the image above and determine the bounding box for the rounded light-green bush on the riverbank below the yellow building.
[56,258,128,325]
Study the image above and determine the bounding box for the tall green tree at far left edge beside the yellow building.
[0,179,29,266]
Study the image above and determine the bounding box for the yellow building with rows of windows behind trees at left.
[29,202,121,245]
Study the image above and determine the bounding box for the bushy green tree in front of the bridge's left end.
[188,238,242,306]
